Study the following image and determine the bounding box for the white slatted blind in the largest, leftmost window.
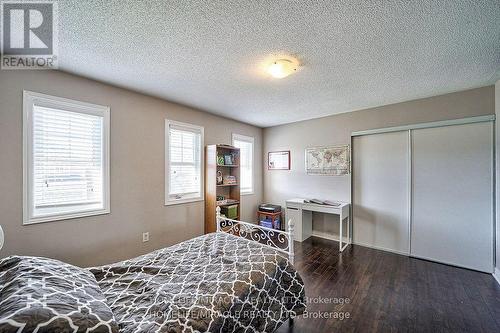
[32,105,104,216]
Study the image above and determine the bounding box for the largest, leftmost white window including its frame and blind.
[23,91,109,224]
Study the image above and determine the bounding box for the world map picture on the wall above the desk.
[306,145,351,176]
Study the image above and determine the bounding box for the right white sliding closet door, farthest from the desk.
[411,122,493,272]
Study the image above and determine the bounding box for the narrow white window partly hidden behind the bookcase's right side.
[233,133,253,194]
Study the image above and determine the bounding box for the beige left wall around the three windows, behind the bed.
[0,71,263,266]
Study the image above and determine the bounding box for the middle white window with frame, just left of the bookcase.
[165,120,204,205]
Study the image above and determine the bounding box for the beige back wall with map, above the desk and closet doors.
[263,86,495,234]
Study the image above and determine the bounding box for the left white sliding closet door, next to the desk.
[352,131,410,254]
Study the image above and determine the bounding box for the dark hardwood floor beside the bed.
[277,237,500,333]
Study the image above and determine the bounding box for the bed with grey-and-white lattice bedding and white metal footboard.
[0,211,306,333]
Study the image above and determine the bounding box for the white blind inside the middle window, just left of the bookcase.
[168,124,201,200]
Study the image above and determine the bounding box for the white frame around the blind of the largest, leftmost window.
[23,90,111,225]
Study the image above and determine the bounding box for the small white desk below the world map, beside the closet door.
[286,199,351,252]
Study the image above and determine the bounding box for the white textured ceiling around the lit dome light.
[59,0,500,127]
